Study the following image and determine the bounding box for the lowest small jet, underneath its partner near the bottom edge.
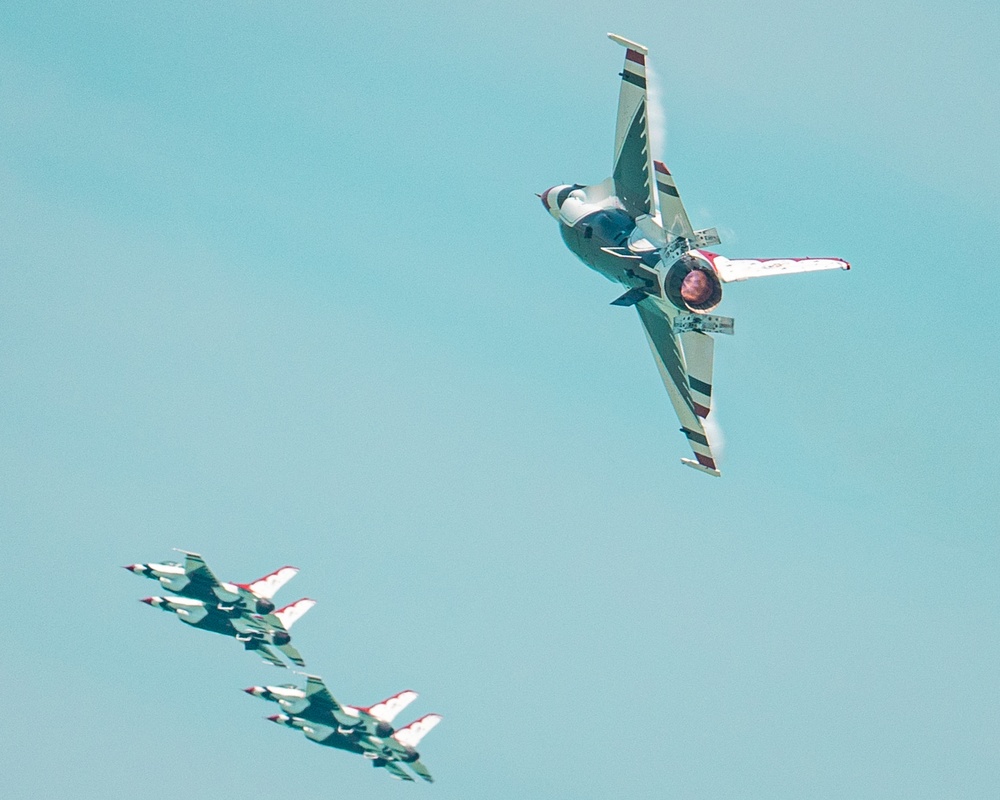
[268,714,441,783]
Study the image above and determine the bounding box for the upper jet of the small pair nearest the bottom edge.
[243,675,419,738]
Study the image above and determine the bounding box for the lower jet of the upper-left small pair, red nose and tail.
[142,596,316,667]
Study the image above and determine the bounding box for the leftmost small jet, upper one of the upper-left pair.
[125,550,299,614]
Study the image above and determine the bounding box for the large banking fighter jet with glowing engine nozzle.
[539,33,851,476]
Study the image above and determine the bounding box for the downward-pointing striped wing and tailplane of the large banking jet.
[635,296,721,477]
